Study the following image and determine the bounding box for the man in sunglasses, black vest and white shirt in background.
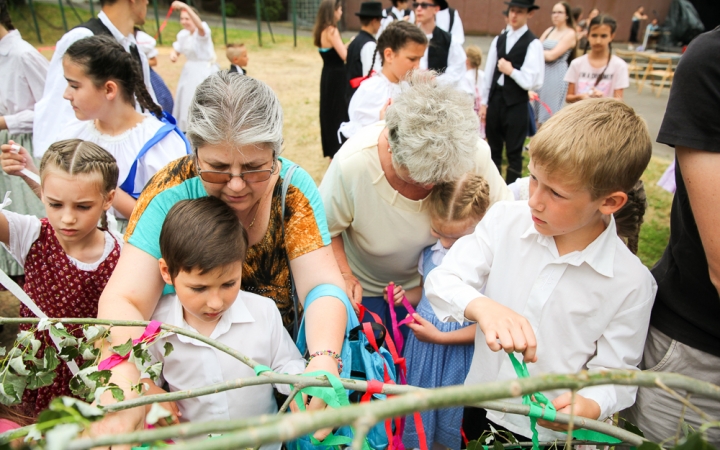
[413,0,467,86]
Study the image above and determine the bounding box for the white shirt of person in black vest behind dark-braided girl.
[33,11,155,158]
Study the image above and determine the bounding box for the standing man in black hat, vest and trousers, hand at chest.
[480,0,545,184]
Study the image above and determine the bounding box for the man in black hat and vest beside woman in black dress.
[345,2,383,102]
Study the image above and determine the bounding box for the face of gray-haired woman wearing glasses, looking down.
[197,144,278,213]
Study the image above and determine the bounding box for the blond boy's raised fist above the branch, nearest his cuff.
[465,297,537,362]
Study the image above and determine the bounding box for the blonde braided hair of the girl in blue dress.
[428,173,490,222]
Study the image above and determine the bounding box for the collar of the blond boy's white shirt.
[520,215,618,277]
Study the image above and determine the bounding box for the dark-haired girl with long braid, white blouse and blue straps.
[3,35,190,232]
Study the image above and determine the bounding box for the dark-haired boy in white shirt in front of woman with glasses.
[144,196,305,449]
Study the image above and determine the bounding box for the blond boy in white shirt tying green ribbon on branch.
[425,99,657,441]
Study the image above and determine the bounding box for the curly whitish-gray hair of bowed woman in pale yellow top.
[386,71,480,184]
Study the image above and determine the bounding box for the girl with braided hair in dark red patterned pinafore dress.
[0,139,122,415]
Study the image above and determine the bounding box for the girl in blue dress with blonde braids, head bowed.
[394,174,490,449]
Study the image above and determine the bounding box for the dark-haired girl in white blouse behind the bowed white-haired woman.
[338,20,428,139]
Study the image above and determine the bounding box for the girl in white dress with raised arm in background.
[170,1,218,131]
